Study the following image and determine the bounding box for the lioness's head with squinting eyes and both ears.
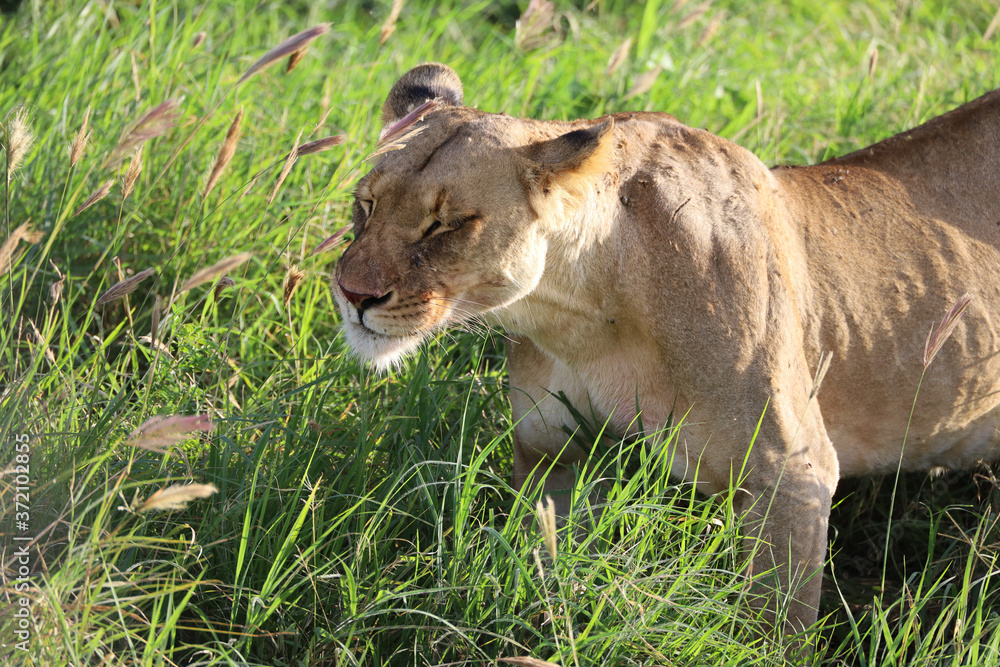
[333,63,613,367]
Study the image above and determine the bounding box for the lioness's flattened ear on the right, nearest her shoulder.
[525,118,615,193]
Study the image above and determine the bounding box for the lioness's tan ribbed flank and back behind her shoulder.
[773,100,1000,475]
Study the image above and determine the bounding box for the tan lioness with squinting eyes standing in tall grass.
[334,63,1000,632]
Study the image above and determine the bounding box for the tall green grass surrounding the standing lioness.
[0,0,1000,665]
